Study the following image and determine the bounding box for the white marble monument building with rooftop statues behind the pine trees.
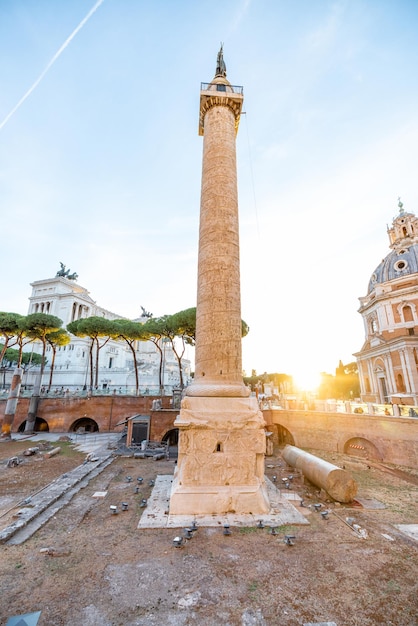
[24,273,190,394]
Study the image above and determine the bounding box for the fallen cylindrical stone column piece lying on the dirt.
[282,445,357,502]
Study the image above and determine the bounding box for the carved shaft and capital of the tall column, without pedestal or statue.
[186,75,249,396]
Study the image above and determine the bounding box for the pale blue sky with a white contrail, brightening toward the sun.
[0,0,418,384]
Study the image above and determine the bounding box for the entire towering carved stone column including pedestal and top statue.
[170,47,269,515]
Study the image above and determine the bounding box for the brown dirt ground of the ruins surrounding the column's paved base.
[0,441,418,626]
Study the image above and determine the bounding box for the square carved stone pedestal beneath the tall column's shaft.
[170,397,270,515]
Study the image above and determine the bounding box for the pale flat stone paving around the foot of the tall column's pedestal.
[138,475,309,529]
